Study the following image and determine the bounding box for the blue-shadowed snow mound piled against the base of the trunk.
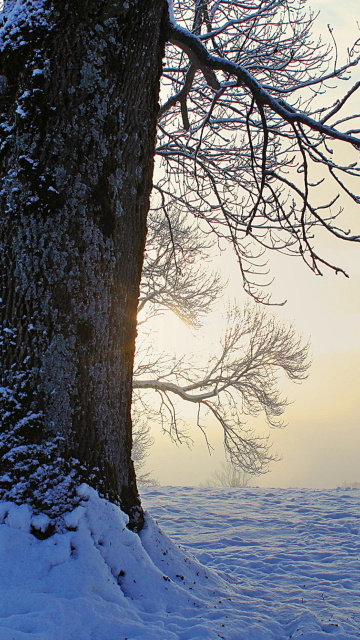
[0,485,242,640]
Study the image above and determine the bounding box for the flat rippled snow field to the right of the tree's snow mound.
[143,487,360,640]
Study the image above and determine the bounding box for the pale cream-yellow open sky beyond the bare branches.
[141,0,360,488]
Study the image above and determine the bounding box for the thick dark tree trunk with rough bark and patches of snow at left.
[0,0,167,528]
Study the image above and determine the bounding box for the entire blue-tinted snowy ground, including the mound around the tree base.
[0,487,360,640]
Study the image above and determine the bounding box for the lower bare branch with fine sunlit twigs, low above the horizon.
[133,306,309,473]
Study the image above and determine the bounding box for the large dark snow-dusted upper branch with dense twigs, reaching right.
[157,0,360,303]
